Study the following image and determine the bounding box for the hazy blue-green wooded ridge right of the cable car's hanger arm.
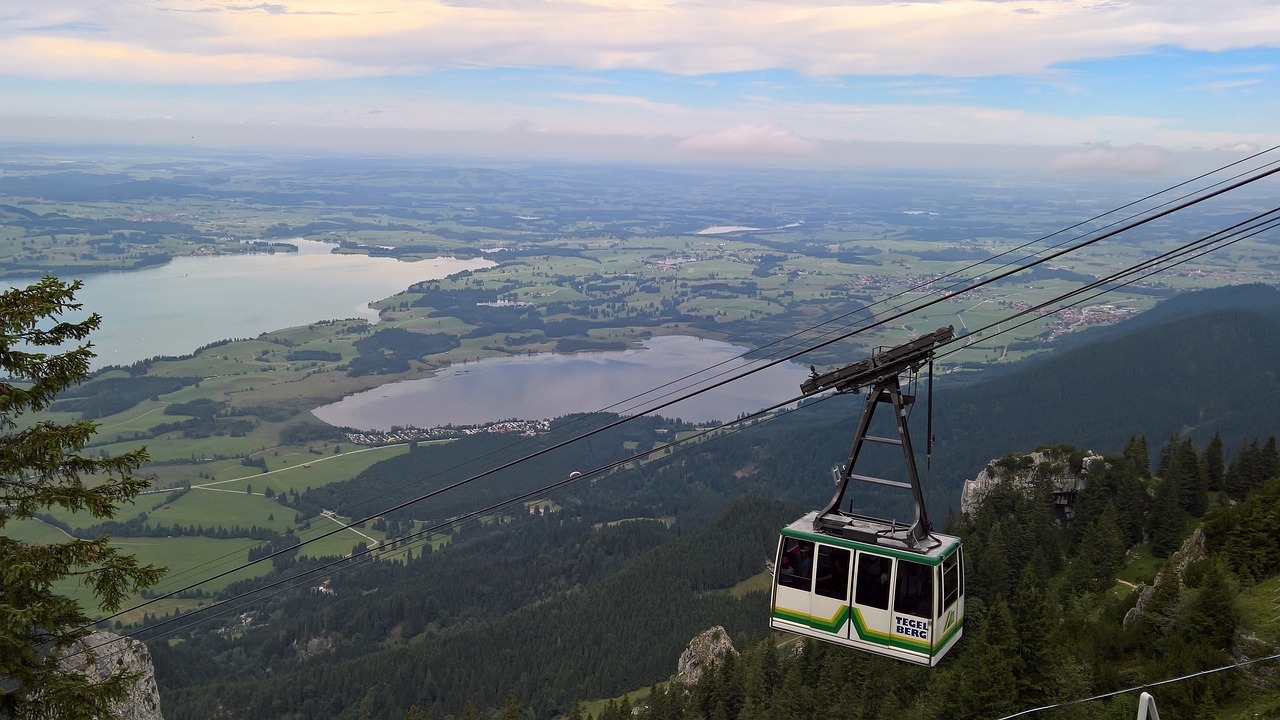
[922,280,1280,503]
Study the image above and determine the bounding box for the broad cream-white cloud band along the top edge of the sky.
[0,0,1280,83]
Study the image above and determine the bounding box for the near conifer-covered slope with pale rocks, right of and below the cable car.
[599,430,1280,720]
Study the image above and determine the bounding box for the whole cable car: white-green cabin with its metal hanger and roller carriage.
[769,327,964,666]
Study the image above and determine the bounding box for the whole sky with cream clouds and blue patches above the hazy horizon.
[0,0,1280,174]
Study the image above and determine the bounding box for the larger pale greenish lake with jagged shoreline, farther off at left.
[8,240,493,368]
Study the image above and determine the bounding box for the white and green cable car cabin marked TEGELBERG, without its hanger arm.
[769,512,964,667]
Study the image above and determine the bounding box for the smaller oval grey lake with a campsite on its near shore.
[312,336,809,430]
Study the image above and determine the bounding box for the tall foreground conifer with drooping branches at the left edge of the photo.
[0,277,164,717]
